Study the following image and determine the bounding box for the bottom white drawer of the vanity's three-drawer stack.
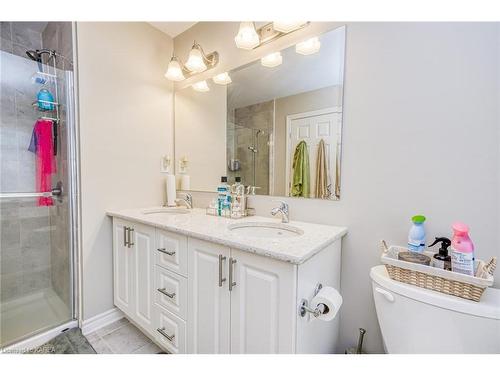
[153,305,186,354]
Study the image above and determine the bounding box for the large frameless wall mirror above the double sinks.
[175,27,345,200]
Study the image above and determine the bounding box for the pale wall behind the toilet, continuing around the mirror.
[174,23,500,352]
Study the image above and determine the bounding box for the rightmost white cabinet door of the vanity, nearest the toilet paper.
[229,249,297,354]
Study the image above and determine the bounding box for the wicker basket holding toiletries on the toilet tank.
[381,241,496,302]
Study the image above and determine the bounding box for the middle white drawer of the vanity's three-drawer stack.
[155,266,187,319]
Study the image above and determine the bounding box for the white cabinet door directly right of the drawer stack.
[188,238,230,354]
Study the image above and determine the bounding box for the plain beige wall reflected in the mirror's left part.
[175,84,227,191]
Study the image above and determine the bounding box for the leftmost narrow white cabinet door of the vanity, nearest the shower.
[113,219,133,315]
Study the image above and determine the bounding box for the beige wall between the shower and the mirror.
[77,22,173,319]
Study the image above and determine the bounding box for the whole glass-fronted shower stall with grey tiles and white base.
[0,22,78,349]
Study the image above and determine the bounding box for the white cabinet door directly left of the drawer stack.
[130,223,155,331]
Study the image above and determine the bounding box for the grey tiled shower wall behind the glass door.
[0,22,72,304]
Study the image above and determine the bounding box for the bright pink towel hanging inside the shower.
[29,120,56,206]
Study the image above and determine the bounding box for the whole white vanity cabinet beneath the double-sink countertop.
[113,217,340,354]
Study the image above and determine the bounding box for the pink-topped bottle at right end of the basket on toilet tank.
[451,222,474,276]
